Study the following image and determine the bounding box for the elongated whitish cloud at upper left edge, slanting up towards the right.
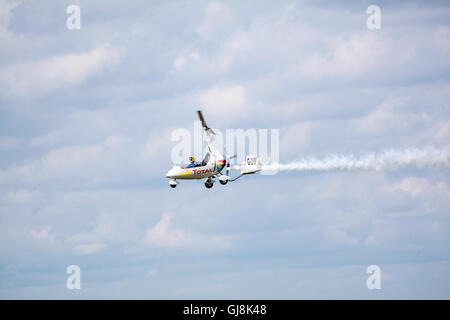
[0,45,121,98]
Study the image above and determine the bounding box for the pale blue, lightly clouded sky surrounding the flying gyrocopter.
[0,0,450,299]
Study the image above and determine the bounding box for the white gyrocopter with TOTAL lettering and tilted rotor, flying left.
[166,111,261,188]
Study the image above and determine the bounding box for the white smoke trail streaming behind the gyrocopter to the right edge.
[232,147,450,171]
